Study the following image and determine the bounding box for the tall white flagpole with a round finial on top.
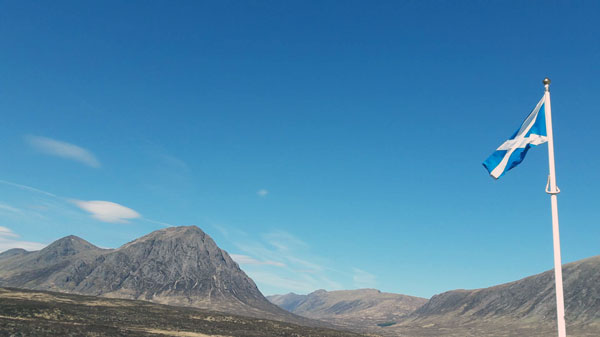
[544,77,567,337]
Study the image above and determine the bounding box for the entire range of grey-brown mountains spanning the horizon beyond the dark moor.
[0,226,600,337]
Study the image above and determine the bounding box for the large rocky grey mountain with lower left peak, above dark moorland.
[0,226,315,325]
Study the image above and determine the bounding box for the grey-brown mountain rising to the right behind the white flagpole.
[400,256,600,328]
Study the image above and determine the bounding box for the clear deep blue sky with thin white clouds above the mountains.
[0,0,600,297]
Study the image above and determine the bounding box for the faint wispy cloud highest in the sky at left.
[26,136,100,167]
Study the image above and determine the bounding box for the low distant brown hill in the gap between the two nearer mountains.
[267,289,427,330]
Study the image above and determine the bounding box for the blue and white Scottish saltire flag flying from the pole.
[483,97,548,179]
